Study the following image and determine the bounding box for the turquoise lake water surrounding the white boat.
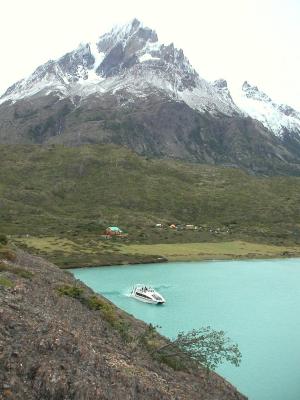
[72,259,300,400]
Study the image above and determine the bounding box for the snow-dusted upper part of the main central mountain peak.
[0,19,239,115]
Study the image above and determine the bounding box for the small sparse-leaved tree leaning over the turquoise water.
[154,326,242,371]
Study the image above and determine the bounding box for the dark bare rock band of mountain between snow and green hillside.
[0,92,300,174]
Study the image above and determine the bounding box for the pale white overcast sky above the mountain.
[0,0,300,111]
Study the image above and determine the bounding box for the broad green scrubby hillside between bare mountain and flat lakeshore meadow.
[0,145,300,266]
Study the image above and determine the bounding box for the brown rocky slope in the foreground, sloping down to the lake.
[0,250,245,400]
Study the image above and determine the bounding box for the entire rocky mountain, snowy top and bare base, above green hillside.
[0,19,300,173]
